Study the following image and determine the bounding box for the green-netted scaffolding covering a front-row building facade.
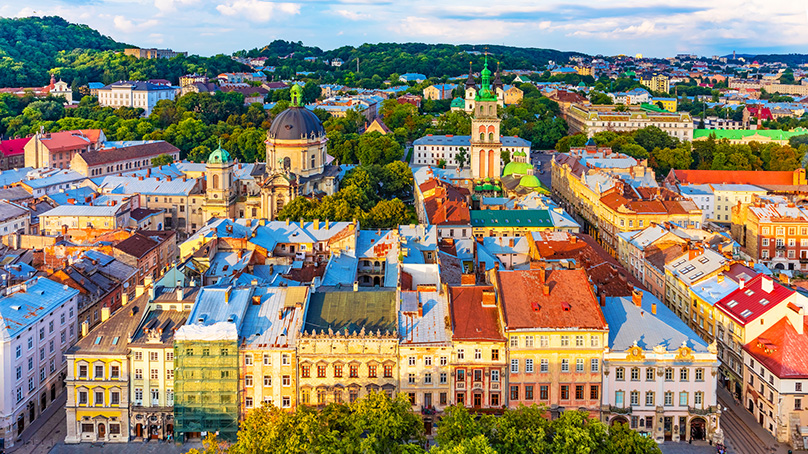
[174,339,241,441]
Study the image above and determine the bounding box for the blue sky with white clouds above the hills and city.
[6,0,808,57]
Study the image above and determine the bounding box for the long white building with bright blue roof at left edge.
[0,277,79,448]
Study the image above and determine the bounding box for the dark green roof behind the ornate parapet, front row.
[304,290,396,333]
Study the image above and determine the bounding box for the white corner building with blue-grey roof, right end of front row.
[602,290,723,442]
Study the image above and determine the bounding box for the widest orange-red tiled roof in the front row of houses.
[497,269,607,329]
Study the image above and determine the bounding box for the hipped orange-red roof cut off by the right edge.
[743,317,808,379]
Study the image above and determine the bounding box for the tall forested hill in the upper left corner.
[0,16,126,87]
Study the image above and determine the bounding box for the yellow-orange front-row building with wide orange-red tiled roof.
[495,268,609,416]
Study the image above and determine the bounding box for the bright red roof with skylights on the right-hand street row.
[715,274,794,326]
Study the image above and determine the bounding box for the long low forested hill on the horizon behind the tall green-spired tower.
[239,40,584,77]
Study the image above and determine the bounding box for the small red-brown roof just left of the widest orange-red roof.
[449,285,505,341]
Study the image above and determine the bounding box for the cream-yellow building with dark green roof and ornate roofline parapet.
[297,287,399,405]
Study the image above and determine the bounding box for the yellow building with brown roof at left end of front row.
[65,294,148,443]
